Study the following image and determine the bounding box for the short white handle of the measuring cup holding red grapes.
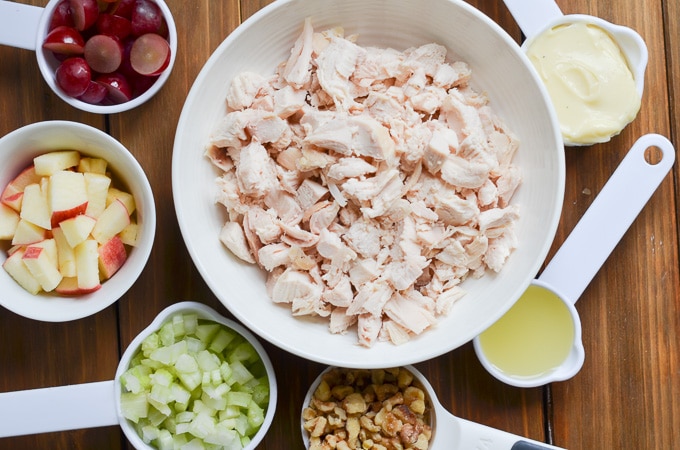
[0,0,44,50]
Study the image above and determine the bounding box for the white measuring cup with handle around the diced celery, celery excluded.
[0,301,277,450]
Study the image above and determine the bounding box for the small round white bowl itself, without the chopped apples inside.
[0,121,156,322]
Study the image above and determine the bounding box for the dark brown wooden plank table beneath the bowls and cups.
[0,0,680,449]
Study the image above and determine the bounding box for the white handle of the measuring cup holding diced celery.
[0,378,119,438]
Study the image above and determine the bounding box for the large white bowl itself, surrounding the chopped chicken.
[172,0,565,368]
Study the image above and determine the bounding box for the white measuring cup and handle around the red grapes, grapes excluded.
[0,0,177,114]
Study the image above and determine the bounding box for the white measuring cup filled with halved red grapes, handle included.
[0,0,177,114]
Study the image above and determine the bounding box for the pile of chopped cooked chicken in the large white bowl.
[206,19,522,347]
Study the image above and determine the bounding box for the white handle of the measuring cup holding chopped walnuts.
[446,416,560,450]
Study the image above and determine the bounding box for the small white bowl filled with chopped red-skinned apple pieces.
[0,121,156,322]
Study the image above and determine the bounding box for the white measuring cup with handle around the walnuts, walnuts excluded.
[300,365,561,450]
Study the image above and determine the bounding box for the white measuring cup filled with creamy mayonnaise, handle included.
[504,0,648,146]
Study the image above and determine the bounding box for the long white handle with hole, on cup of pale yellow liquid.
[538,134,675,303]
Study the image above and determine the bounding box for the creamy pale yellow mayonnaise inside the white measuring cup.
[527,22,640,145]
